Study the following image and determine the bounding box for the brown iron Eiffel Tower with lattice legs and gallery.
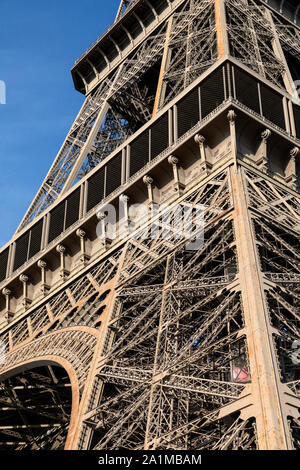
[0,0,300,450]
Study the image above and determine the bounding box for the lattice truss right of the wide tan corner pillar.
[245,167,300,448]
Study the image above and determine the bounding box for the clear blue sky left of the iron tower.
[0,0,120,246]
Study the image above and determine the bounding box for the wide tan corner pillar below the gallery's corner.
[231,164,291,450]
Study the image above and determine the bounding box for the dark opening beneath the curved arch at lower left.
[0,362,72,450]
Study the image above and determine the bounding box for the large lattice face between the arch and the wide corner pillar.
[74,170,256,450]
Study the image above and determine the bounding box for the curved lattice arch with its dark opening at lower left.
[0,327,96,450]
